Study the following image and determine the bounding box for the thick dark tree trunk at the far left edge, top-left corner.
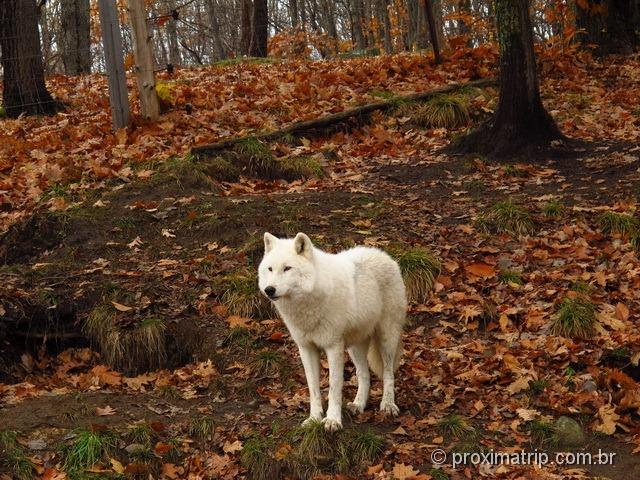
[0,0,60,118]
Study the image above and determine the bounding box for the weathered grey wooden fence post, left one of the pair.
[98,0,129,130]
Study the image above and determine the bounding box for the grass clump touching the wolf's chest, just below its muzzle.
[219,271,271,318]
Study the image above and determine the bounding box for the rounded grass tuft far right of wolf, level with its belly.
[551,296,596,339]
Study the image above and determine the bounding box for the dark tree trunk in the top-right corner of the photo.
[576,0,640,55]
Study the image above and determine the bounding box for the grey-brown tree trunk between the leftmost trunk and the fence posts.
[60,0,91,75]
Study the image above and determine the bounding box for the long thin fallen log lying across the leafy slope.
[191,78,498,156]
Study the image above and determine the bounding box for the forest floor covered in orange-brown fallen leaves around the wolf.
[0,51,640,479]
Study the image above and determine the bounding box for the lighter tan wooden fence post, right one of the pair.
[128,0,160,121]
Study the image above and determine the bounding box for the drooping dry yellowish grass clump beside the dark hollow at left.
[83,304,167,373]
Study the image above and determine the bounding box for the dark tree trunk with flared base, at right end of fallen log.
[453,0,563,157]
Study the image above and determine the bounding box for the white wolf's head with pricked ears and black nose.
[258,233,315,302]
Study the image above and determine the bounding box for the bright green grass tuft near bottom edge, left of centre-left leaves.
[62,429,116,473]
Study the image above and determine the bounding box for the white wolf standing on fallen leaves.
[258,233,407,431]
